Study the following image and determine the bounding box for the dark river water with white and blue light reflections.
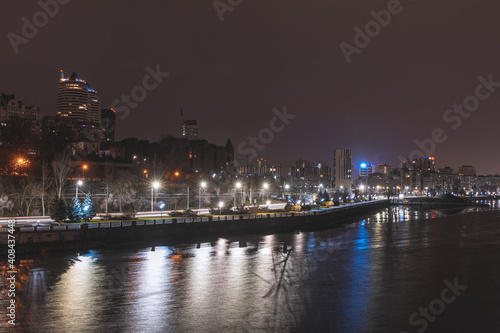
[1,207,500,333]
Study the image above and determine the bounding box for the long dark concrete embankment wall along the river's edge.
[0,200,389,252]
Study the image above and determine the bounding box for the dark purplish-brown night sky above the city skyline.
[0,0,500,174]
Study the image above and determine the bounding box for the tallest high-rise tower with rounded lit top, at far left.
[56,71,101,123]
